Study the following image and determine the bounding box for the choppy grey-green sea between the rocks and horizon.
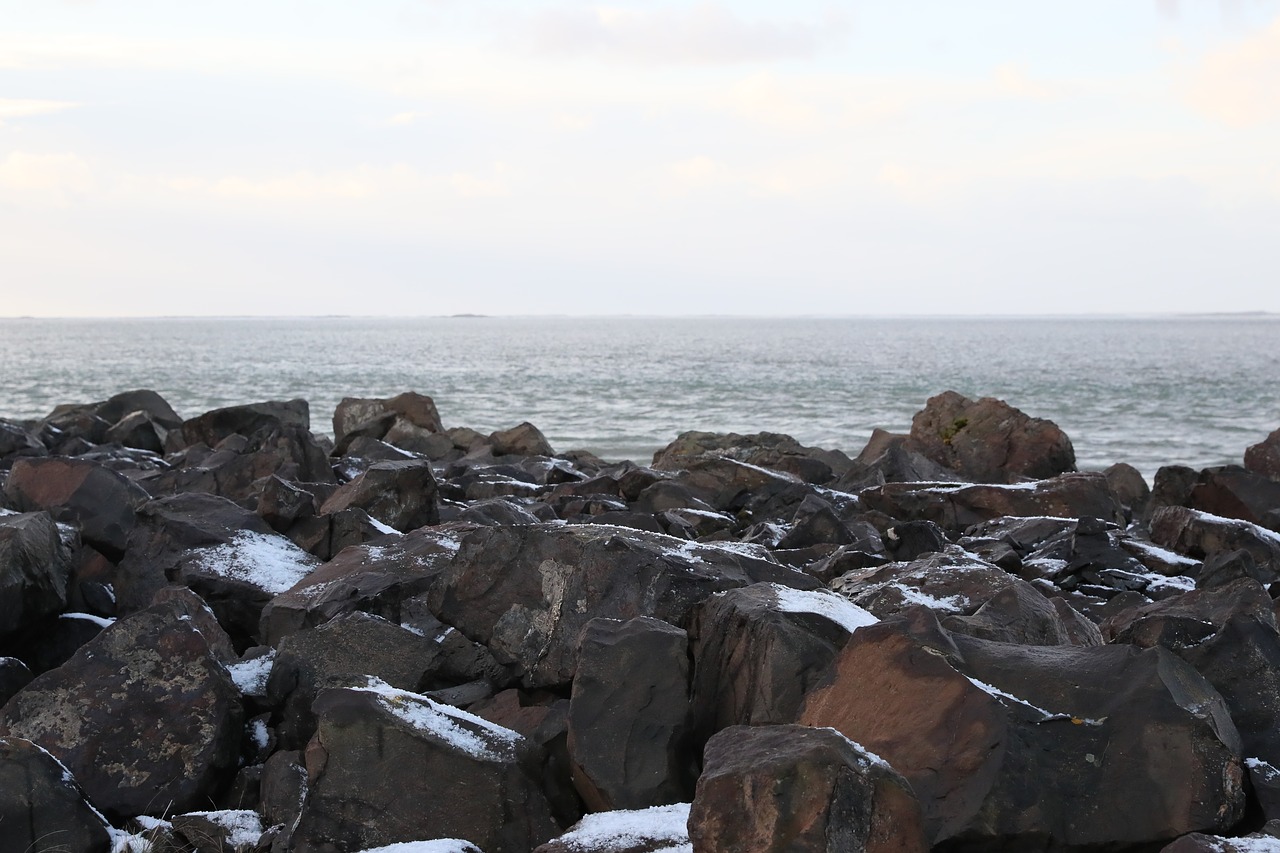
[0,316,1280,479]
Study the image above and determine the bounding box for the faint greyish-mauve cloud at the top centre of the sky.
[525,3,846,65]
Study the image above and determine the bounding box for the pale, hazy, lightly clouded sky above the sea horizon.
[0,0,1280,316]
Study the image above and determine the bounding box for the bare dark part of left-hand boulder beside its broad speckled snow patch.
[115,493,275,615]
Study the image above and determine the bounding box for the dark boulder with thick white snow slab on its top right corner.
[690,583,877,743]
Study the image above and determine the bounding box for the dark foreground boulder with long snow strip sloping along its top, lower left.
[293,679,556,853]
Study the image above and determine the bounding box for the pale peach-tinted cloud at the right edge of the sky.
[1181,18,1280,127]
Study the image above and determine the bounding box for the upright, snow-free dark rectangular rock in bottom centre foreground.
[568,617,695,812]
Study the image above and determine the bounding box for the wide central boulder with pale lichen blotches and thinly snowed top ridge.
[428,524,817,686]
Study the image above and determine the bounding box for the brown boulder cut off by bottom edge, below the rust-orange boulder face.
[689,725,929,853]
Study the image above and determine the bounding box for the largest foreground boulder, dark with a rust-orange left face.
[800,608,1244,850]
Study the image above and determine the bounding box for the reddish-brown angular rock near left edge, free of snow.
[4,459,148,560]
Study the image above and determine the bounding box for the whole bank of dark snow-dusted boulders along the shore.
[0,391,1280,853]
